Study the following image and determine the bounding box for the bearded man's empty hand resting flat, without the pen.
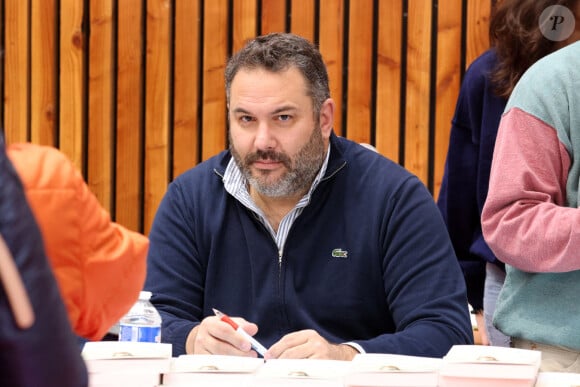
[264,329,358,360]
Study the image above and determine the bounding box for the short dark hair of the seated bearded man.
[225,33,330,115]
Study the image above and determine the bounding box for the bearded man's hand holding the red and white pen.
[185,316,258,357]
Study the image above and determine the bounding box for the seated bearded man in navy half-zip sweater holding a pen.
[145,33,473,360]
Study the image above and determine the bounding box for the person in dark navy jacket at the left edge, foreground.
[0,132,88,387]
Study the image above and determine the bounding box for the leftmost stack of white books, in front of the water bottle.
[82,341,172,387]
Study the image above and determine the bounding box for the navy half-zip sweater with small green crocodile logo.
[145,135,473,357]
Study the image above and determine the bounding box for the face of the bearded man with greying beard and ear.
[229,68,334,197]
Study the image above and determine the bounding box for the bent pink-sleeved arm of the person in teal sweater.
[482,108,580,272]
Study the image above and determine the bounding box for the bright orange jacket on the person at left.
[7,144,149,340]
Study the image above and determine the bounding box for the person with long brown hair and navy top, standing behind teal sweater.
[437,0,580,346]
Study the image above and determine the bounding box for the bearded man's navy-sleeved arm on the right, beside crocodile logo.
[355,178,473,357]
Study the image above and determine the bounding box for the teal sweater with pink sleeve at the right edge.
[482,42,580,350]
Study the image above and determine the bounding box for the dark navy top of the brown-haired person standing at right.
[437,49,507,310]
